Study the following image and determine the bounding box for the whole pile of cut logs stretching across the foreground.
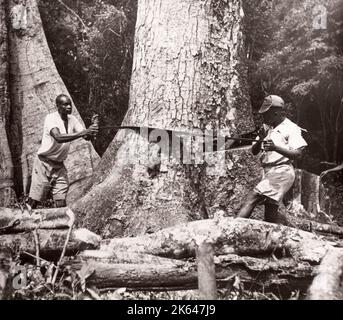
[0,208,343,299]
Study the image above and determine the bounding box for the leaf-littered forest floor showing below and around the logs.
[6,178,343,300]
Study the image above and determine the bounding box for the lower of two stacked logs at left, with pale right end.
[0,229,101,258]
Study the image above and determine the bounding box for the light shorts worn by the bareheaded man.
[29,156,69,202]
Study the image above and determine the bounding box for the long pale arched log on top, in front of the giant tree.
[101,218,333,263]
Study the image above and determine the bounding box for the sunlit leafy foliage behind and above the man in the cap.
[246,0,343,171]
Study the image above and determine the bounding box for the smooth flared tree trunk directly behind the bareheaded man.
[6,0,98,202]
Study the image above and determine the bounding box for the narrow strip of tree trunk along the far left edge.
[0,0,16,207]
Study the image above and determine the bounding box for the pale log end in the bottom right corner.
[307,248,343,300]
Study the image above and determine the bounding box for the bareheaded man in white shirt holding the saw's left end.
[27,94,99,211]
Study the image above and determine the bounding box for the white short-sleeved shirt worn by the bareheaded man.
[37,112,84,162]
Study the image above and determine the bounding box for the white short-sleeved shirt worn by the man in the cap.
[260,118,307,166]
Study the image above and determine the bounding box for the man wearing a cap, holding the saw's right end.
[237,95,307,223]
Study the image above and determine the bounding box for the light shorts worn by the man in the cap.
[254,164,295,203]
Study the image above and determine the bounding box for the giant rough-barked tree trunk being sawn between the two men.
[73,0,257,236]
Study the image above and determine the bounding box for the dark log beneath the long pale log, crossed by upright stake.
[64,251,313,293]
